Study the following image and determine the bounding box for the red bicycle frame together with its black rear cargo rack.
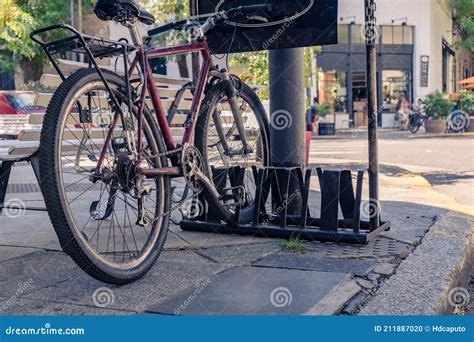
[30,24,217,177]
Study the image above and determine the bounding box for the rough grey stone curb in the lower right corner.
[360,212,474,316]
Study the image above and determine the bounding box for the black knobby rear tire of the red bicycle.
[39,69,171,285]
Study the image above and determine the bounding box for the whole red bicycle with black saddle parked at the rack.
[30,0,271,284]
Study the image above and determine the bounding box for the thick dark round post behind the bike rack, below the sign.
[269,48,306,214]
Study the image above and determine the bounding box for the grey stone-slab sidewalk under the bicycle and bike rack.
[0,160,472,315]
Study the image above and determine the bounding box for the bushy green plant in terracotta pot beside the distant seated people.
[425,90,453,133]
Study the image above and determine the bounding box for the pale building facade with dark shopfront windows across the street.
[317,0,473,127]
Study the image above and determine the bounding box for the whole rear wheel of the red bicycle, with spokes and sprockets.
[39,69,170,284]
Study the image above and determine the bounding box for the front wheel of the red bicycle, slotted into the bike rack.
[194,82,270,223]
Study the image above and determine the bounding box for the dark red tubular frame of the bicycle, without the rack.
[96,40,212,177]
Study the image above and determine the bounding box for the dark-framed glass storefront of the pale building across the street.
[317,24,414,128]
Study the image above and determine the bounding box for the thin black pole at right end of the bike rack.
[365,0,380,230]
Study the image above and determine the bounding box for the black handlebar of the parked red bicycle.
[148,4,273,37]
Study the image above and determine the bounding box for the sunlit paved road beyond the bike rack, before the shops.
[311,132,474,205]
